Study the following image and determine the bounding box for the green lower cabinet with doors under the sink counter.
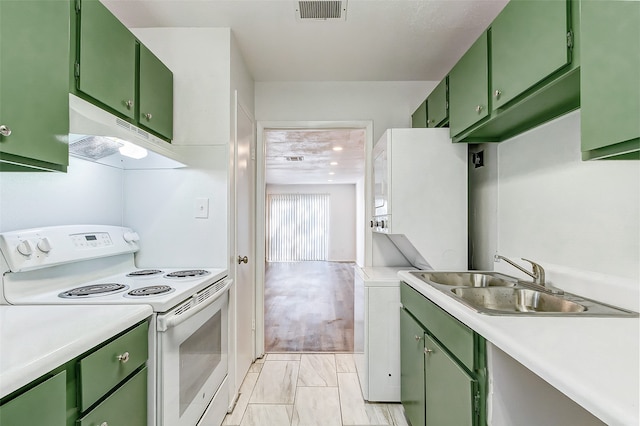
[400,283,486,426]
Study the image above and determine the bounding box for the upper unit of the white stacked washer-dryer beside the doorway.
[371,128,468,270]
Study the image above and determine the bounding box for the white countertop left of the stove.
[0,305,152,397]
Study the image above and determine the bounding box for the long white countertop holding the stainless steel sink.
[398,272,640,426]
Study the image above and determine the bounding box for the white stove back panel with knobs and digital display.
[0,225,140,272]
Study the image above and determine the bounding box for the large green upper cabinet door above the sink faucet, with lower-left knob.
[491,0,571,110]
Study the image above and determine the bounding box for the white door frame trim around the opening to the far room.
[255,120,373,357]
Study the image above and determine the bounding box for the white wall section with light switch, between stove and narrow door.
[124,145,228,268]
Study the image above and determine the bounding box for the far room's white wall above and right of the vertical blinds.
[267,185,357,262]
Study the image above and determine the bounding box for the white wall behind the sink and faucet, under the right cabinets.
[470,111,640,305]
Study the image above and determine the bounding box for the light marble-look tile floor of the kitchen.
[223,353,407,426]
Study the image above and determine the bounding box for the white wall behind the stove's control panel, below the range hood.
[0,157,123,232]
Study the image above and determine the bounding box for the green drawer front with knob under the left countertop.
[78,322,149,412]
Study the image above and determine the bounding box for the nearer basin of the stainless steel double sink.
[451,287,587,313]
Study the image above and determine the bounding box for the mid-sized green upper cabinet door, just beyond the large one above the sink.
[449,32,489,136]
